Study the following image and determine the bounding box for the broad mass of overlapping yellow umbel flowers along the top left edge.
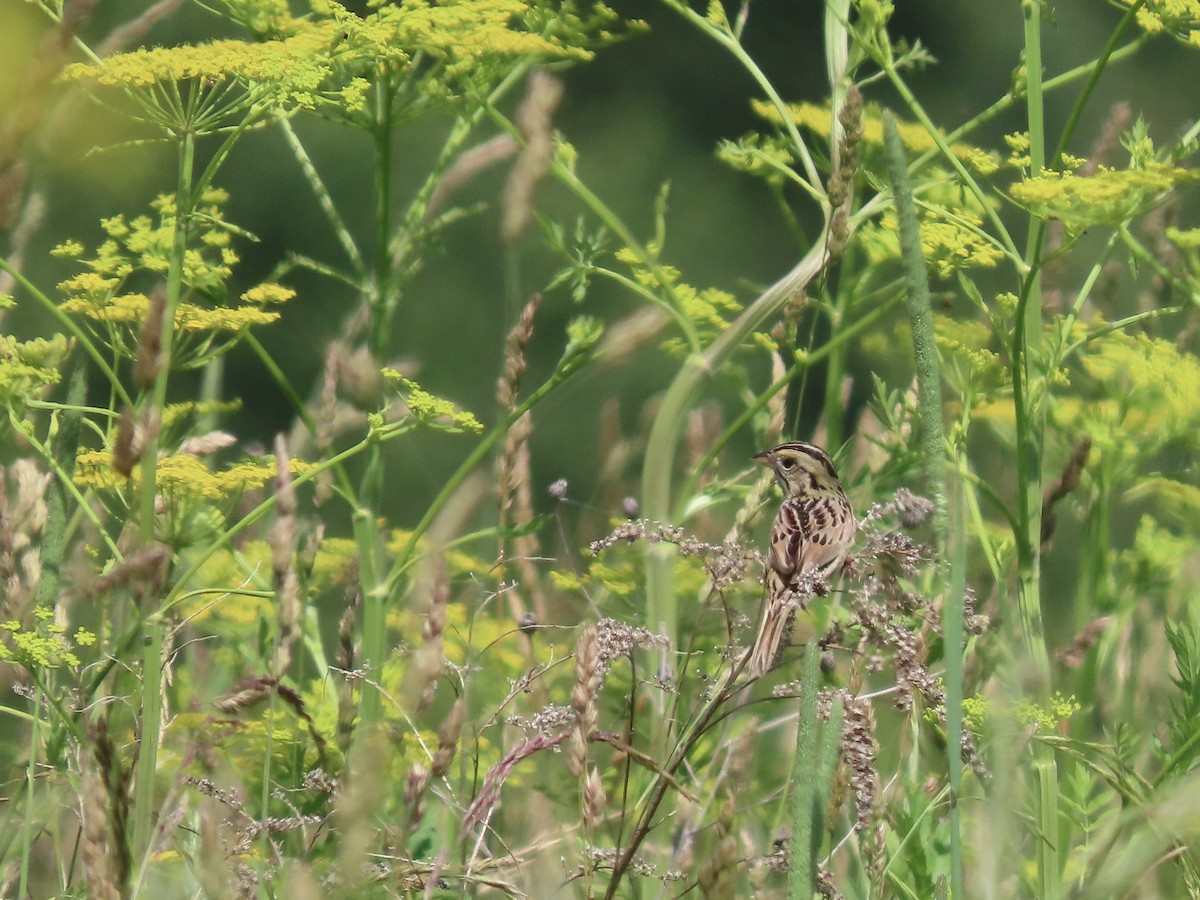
[61,0,614,134]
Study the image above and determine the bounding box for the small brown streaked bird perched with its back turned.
[750,440,857,677]
